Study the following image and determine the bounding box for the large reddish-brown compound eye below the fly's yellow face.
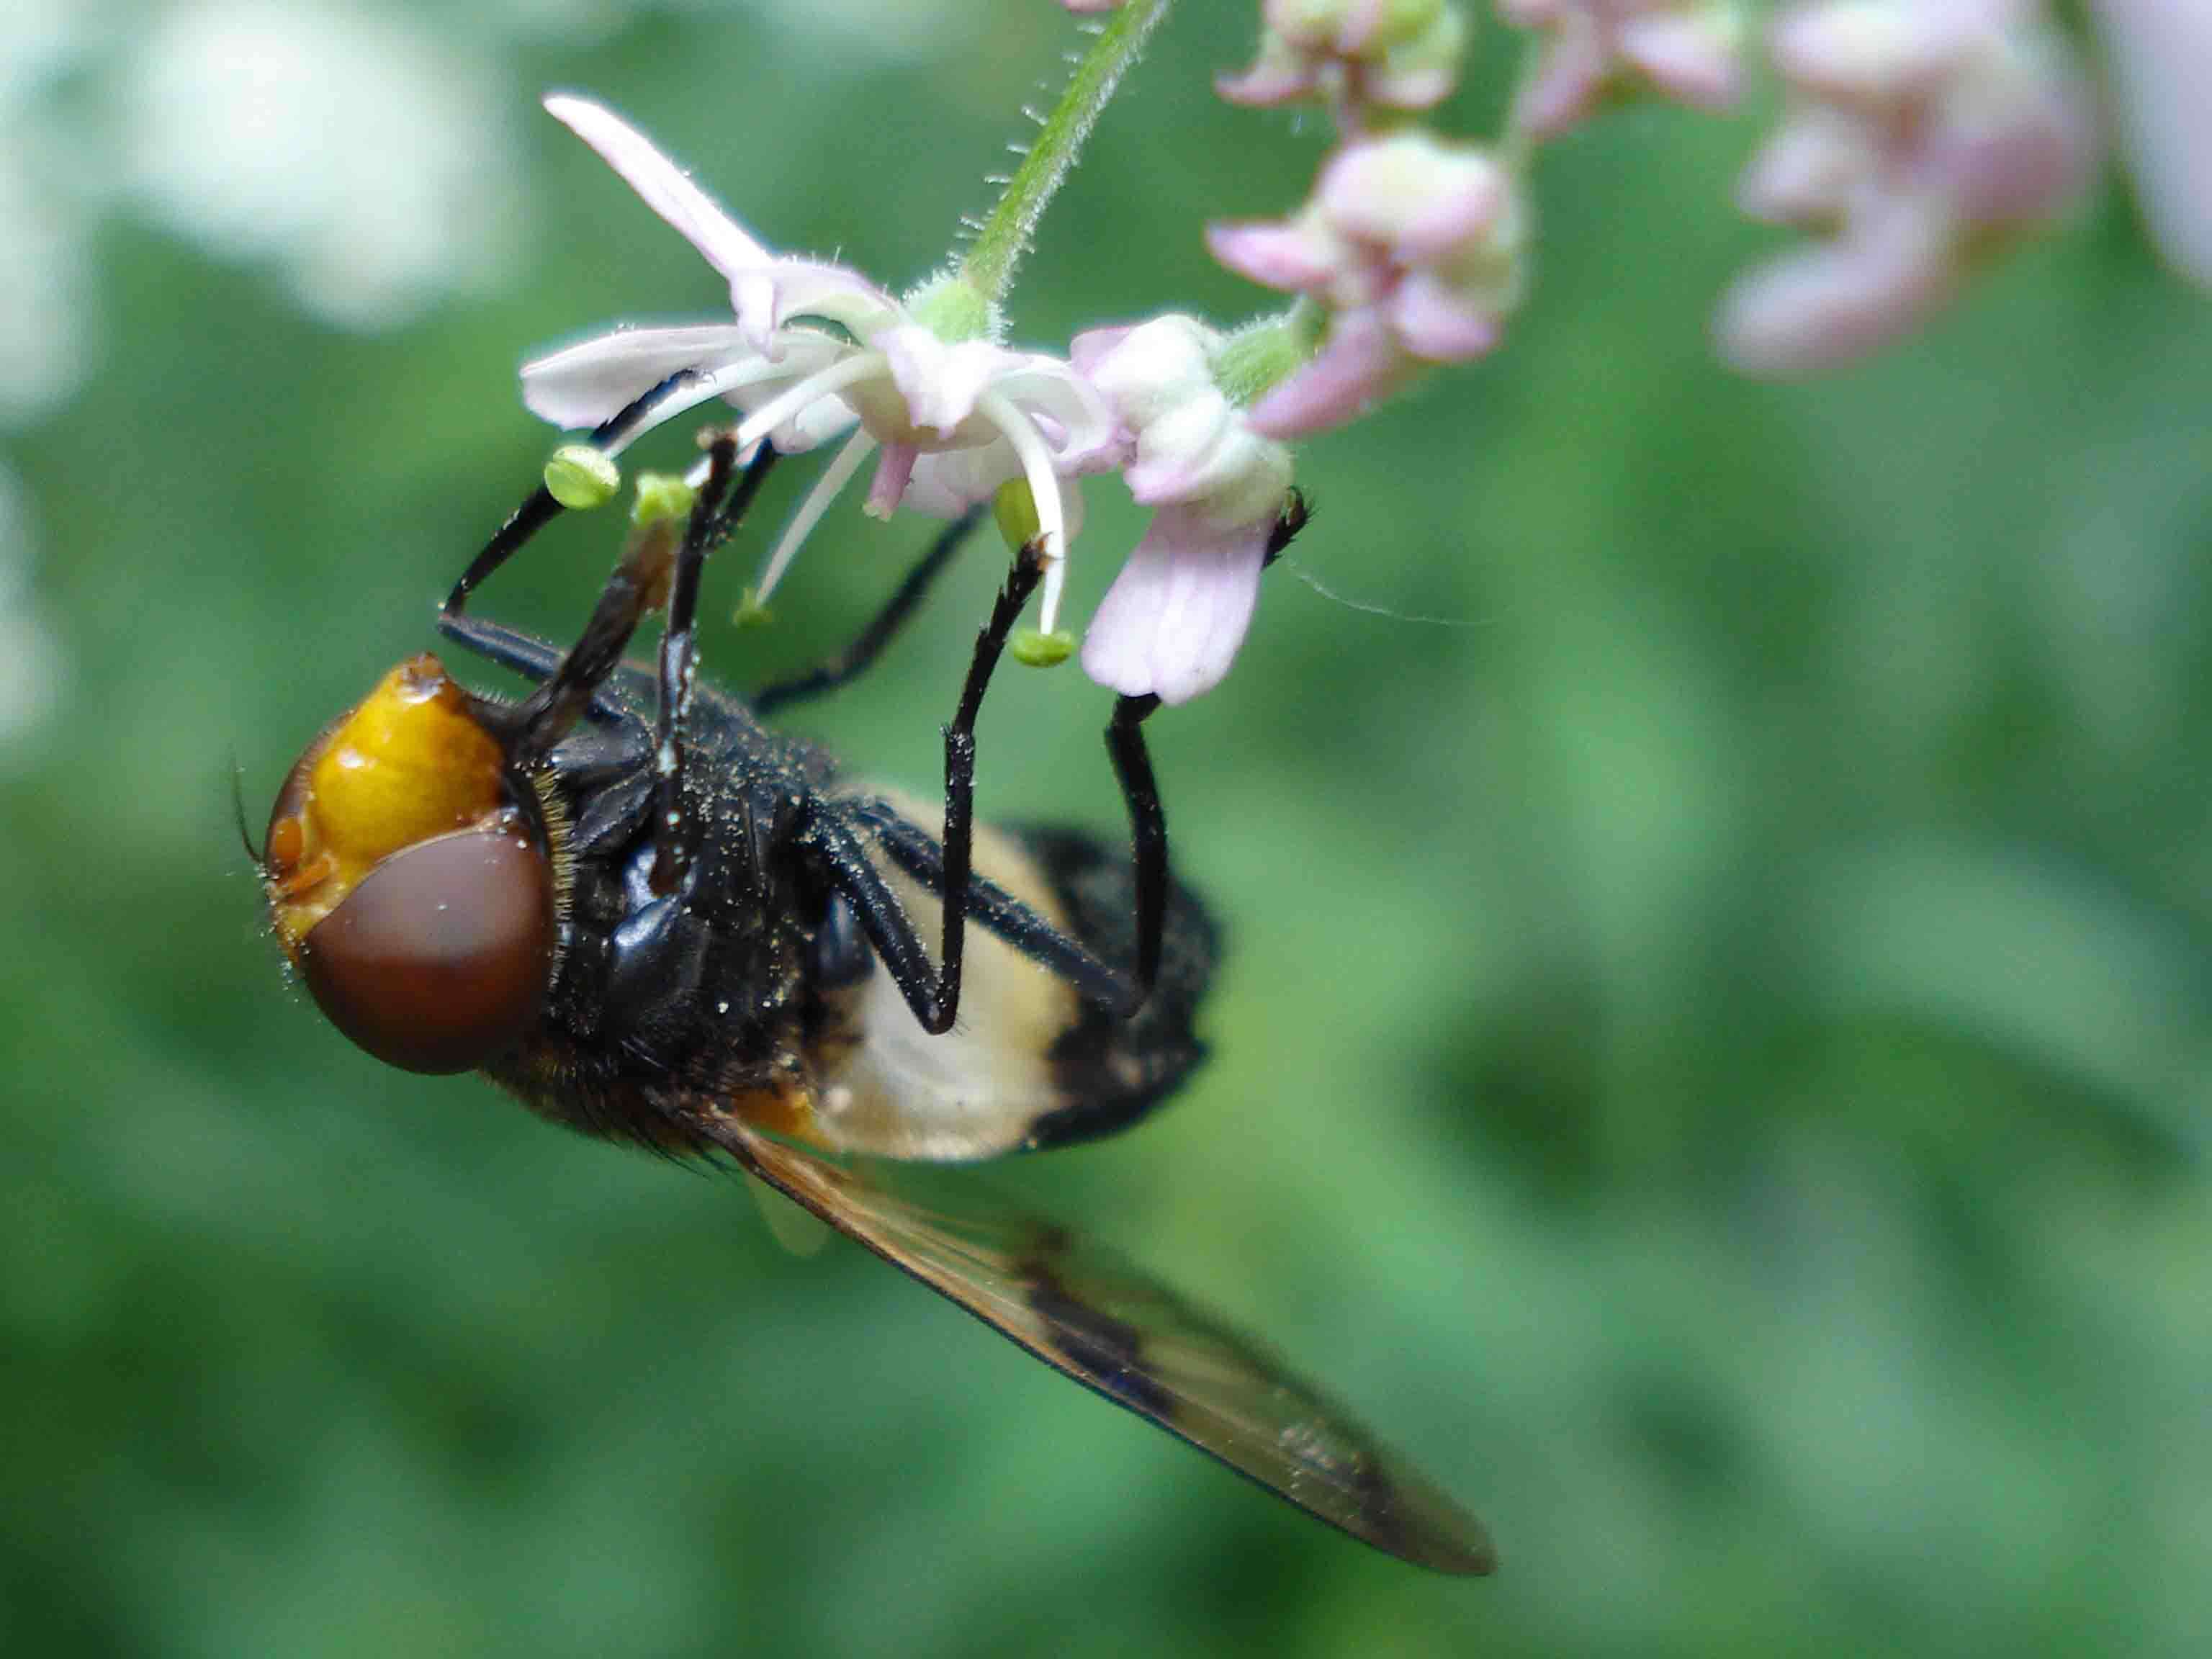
[299,830,555,1073]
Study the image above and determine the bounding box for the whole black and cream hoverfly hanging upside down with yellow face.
[258,407,1493,1573]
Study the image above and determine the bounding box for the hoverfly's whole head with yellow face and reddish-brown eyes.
[261,657,559,1073]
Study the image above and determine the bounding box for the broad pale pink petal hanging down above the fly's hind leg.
[1084,506,1274,703]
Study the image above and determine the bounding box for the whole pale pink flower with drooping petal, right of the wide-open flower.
[1071,316,1290,703]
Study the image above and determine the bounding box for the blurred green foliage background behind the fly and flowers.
[0,0,2212,1655]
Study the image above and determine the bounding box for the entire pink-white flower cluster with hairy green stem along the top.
[522,0,2212,703]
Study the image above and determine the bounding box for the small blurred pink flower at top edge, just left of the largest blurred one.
[1498,0,1743,137]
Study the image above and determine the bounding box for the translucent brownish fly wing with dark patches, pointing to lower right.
[726,1122,1498,1573]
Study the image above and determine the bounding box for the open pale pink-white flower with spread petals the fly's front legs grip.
[522,95,1115,631]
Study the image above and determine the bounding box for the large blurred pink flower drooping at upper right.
[1714,0,2092,376]
